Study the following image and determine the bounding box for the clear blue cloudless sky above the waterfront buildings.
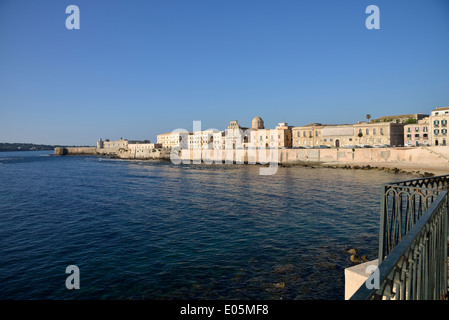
[0,0,449,145]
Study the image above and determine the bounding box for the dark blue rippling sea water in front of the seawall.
[0,151,409,300]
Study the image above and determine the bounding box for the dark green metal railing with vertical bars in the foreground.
[351,176,449,300]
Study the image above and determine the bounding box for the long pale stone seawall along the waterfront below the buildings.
[55,146,449,170]
